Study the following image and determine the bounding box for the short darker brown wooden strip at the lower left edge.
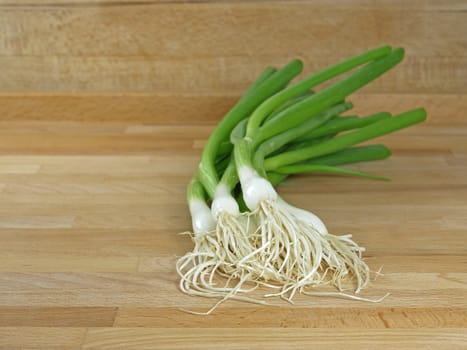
[0,306,117,326]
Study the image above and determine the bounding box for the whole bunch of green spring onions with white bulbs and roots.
[177,46,426,313]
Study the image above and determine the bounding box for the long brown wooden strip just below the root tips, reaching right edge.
[114,305,467,330]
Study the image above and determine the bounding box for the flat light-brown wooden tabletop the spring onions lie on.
[0,117,467,349]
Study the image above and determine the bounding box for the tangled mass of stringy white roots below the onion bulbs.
[176,200,386,315]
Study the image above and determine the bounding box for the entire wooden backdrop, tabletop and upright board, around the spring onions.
[0,0,467,350]
